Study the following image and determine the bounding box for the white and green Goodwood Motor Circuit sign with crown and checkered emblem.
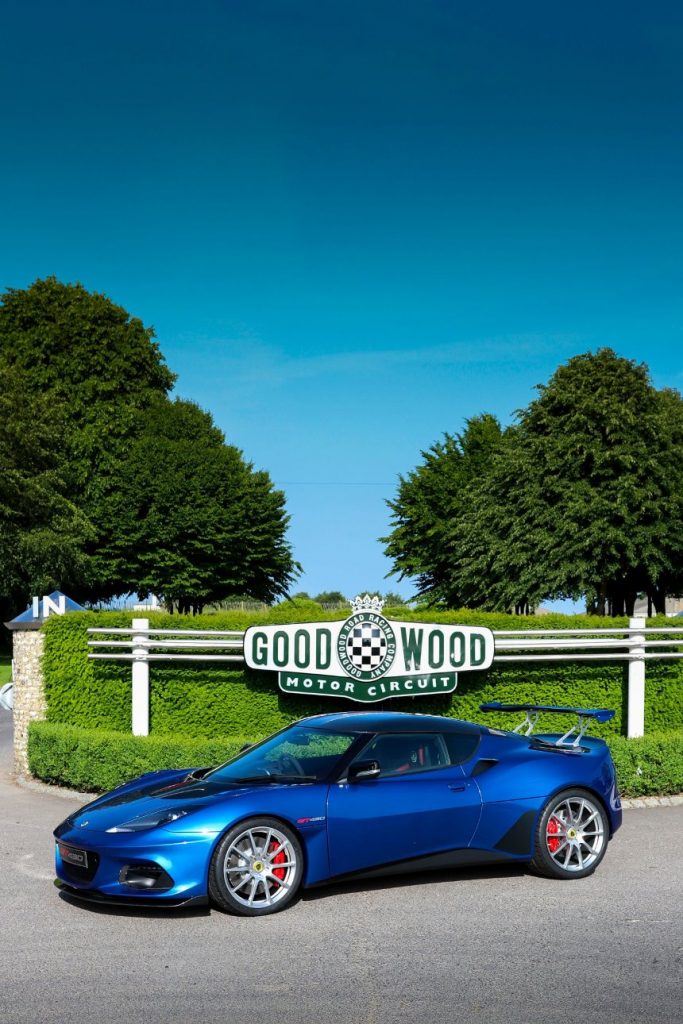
[245,595,494,701]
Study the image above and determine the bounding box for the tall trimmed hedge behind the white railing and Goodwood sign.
[43,600,683,738]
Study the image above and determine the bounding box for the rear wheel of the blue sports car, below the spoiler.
[531,790,609,879]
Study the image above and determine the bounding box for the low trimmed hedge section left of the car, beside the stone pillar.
[29,722,254,793]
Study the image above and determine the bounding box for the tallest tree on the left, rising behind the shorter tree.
[0,278,175,599]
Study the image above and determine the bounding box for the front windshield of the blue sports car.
[207,725,358,783]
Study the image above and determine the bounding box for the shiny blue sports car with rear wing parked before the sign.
[54,703,622,915]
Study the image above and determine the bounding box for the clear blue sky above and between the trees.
[0,0,683,595]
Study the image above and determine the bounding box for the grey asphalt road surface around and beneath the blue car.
[0,711,683,1024]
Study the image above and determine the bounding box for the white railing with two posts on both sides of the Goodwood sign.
[88,618,683,736]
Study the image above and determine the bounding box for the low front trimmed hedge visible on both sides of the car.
[29,722,683,797]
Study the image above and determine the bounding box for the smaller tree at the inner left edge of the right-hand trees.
[381,414,504,607]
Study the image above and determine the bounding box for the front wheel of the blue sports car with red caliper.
[209,817,303,918]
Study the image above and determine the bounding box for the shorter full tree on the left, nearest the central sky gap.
[93,399,299,612]
